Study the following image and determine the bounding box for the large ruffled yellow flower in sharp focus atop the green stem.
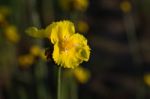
[25,20,90,68]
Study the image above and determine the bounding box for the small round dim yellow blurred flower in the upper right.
[120,1,132,13]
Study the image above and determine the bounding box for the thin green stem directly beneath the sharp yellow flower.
[57,67,61,99]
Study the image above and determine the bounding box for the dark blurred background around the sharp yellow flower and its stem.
[0,0,150,99]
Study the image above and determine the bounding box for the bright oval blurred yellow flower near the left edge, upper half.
[4,26,20,43]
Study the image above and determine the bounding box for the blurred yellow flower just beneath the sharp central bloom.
[73,66,90,83]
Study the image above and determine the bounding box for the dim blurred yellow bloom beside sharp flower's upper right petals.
[77,21,89,33]
